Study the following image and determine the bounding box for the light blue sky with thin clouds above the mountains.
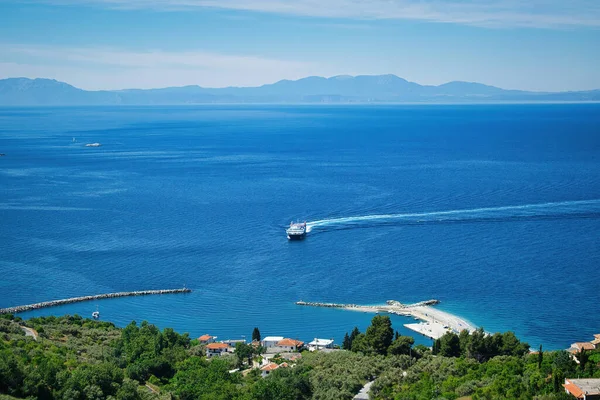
[0,0,600,91]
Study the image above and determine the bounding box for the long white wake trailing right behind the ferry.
[306,199,600,232]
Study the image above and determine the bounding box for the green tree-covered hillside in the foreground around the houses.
[0,315,600,400]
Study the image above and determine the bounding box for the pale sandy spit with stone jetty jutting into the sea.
[296,300,477,339]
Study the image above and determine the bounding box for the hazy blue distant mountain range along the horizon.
[0,75,600,106]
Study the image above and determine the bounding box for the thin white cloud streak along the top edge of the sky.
[21,0,600,27]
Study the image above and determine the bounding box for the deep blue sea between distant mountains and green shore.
[0,104,600,349]
